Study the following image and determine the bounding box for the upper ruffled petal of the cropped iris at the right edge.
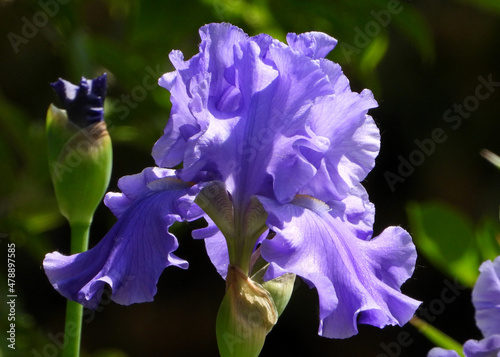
[472,256,500,337]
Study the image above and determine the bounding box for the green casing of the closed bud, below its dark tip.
[46,104,113,226]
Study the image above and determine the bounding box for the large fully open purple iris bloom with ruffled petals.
[44,23,420,338]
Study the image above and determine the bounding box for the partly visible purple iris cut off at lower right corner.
[427,256,500,357]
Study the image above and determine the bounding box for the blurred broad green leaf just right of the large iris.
[407,202,481,287]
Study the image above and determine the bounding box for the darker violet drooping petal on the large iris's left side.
[43,168,201,309]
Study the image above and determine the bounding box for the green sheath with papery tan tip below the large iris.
[216,265,278,357]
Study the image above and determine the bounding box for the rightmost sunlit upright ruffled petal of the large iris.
[304,60,380,201]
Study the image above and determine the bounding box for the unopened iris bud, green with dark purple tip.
[46,74,112,224]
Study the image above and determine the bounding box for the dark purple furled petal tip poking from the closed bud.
[51,73,107,128]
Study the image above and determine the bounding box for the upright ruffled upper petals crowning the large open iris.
[153,24,379,203]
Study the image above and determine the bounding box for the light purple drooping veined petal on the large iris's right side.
[259,196,420,338]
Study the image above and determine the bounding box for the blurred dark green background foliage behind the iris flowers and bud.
[0,0,500,357]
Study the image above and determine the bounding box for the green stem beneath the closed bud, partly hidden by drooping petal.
[63,223,90,357]
